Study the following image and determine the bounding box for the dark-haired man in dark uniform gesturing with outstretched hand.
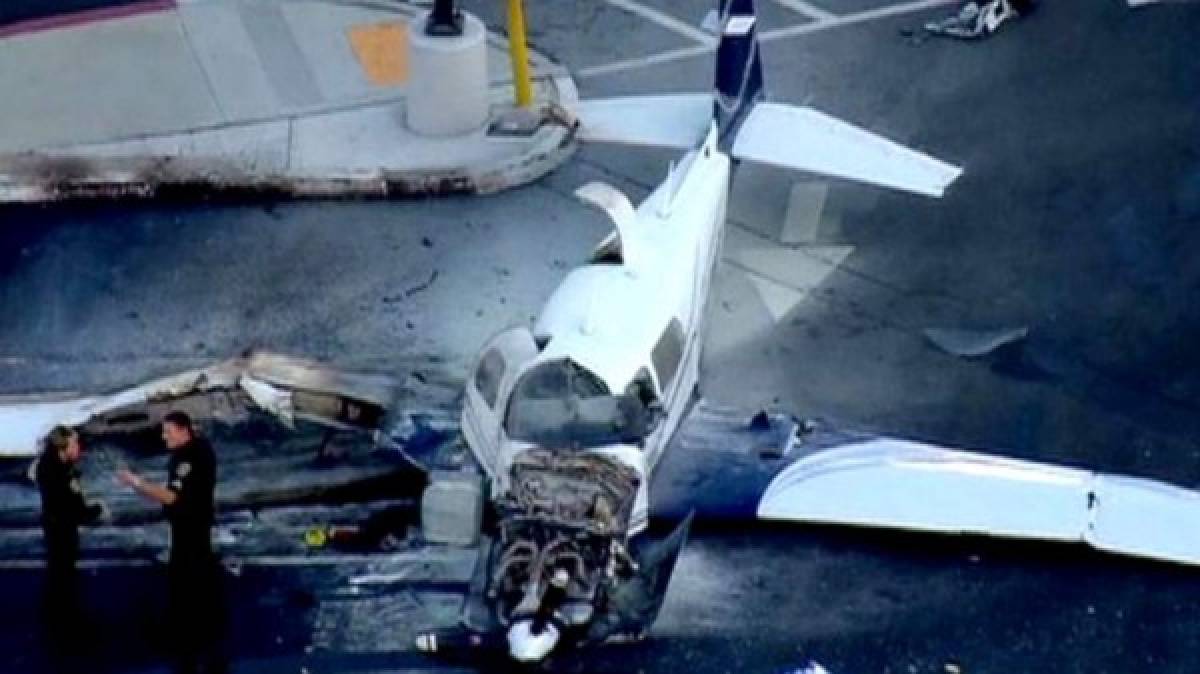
[118,411,226,673]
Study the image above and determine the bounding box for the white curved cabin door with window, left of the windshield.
[462,327,538,482]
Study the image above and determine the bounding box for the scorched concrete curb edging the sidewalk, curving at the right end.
[0,74,577,203]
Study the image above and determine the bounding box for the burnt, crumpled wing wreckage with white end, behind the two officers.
[0,354,394,457]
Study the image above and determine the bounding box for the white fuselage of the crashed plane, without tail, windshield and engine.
[463,125,731,532]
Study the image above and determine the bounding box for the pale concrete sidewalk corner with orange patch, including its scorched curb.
[0,0,576,201]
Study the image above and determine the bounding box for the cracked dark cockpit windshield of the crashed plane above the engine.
[504,360,655,449]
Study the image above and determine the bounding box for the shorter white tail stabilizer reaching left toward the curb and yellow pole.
[574,94,713,150]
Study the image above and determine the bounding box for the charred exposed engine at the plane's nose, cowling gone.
[487,449,640,627]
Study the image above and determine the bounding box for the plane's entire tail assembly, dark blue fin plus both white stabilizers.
[576,0,962,197]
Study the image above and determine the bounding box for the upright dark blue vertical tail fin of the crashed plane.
[713,0,766,143]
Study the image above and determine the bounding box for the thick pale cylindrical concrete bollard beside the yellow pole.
[407,12,488,136]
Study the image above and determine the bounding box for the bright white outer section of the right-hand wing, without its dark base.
[758,438,1200,564]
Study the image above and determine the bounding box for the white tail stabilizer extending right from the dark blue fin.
[733,103,962,197]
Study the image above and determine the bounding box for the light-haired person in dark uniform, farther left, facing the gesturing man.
[35,426,104,634]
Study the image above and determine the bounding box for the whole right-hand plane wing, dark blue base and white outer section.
[652,398,1200,564]
